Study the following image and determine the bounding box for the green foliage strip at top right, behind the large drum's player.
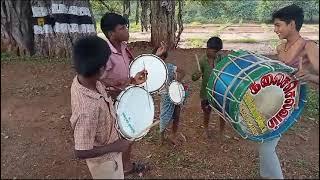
[183,0,319,24]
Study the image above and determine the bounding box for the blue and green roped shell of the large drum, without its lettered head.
[207,51,306,141]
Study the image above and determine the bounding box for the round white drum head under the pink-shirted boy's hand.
[129,54,168,94]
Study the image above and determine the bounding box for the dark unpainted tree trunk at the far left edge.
[1,0,33,55]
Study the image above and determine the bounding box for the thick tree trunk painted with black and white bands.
[32,0,96,57]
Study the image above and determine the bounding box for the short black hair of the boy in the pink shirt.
[100,13,129,36]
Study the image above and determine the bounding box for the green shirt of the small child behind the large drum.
[192,54,223,99]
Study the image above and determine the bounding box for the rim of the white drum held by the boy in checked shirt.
[115,85,155,140]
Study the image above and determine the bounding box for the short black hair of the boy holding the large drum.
[272,4,304,31]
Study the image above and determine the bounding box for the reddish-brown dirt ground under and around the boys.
[1,43,319,179]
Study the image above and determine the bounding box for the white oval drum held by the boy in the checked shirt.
[115,86,154,140]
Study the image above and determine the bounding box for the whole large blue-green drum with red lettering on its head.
[207,50,306,142]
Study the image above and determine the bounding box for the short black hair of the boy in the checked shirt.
[72,36,111,77]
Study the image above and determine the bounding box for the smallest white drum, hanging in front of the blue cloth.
[168,80,186,105]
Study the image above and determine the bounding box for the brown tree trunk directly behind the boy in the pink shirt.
[150,0,176,49]
